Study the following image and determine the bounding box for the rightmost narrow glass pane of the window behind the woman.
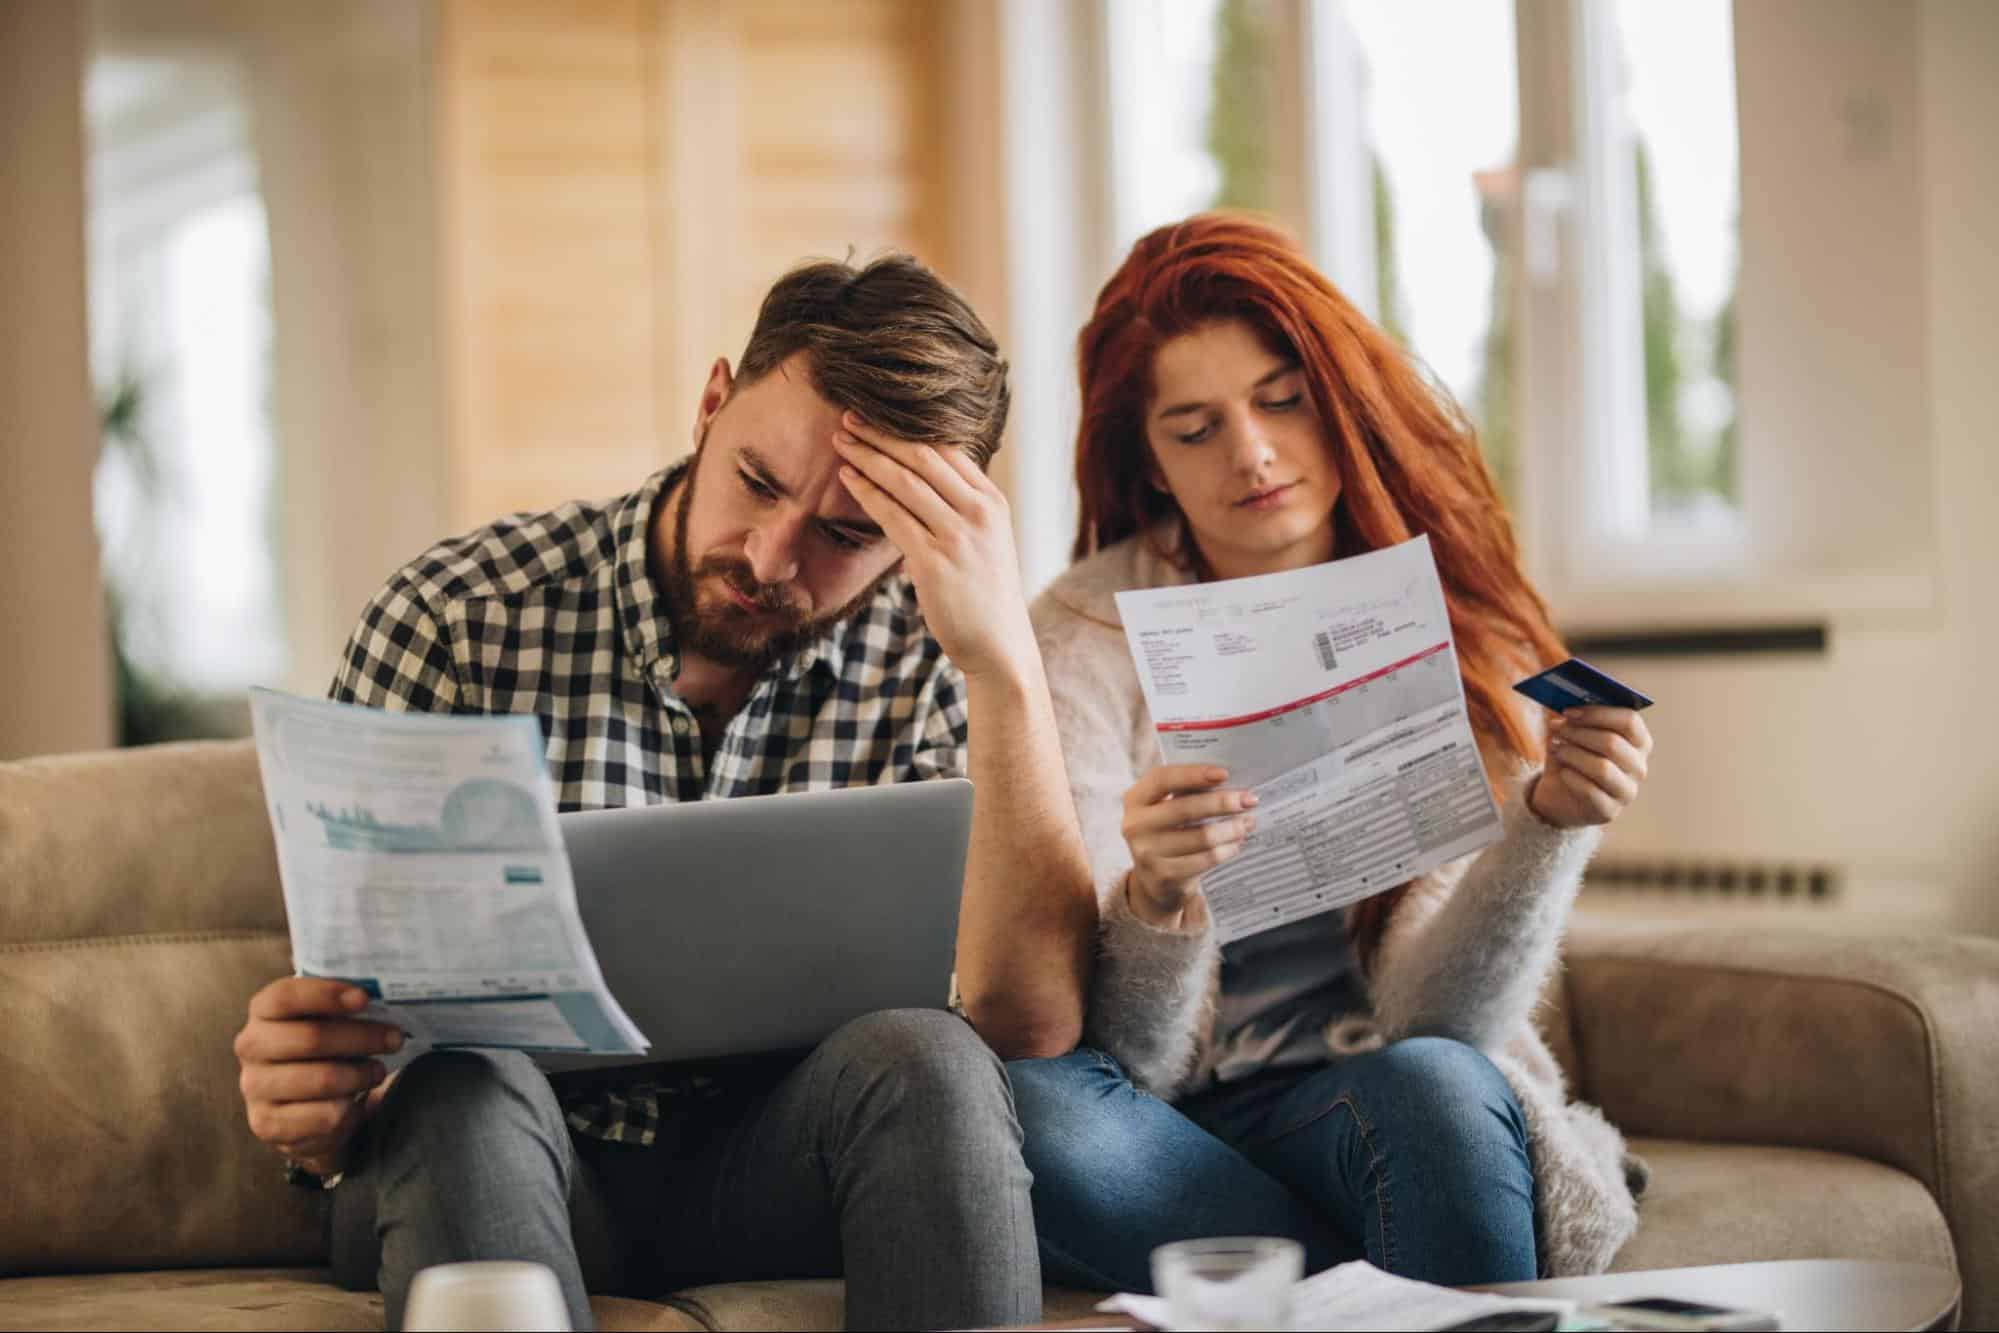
[1573,0,1739,550]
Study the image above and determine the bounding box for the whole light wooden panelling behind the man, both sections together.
[438,0,966,526]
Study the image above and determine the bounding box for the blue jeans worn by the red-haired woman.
[1007,1037,1535,1291]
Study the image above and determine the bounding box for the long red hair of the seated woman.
[1073,212,1565,961]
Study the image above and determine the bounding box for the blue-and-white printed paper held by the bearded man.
[250,689,648,1063]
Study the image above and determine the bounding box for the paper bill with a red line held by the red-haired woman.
[1117,538,1499,943]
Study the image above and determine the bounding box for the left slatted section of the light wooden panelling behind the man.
[438,0,660,528]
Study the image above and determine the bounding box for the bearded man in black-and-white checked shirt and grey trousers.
[236,256,1095,1329]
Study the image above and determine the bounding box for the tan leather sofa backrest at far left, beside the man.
[0,741,326,1273]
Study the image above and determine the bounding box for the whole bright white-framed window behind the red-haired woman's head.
[1107,0,1791,607]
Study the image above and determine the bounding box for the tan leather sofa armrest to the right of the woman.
[1565,917,1999,1327]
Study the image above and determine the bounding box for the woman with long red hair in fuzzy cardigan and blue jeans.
[1007,214,1651,1291]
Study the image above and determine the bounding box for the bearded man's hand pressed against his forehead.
[834,412,1035,677]
